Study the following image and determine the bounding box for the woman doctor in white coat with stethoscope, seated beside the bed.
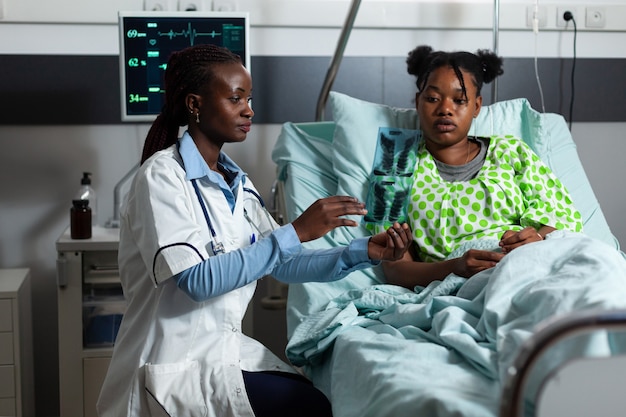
[98,45,412,417]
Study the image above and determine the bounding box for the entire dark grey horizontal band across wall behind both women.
[0,55,626,125]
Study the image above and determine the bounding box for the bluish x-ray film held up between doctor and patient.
[364,127,420,229]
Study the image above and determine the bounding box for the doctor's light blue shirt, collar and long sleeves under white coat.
[174,132,375,301]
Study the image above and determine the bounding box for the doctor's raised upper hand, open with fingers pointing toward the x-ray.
[291,196,367,242]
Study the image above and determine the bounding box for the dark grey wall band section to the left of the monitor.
[0,55,120,125]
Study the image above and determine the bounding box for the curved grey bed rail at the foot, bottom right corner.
[500,310,626,417]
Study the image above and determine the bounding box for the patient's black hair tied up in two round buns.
[406,45,504,98]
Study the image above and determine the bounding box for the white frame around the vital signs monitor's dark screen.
[118,11,251,122]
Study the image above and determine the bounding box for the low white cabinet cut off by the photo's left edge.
[0,268,35,417]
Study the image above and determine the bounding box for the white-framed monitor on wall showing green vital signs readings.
[119,12,250,122]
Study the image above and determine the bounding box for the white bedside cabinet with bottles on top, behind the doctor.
[56,227,120,417]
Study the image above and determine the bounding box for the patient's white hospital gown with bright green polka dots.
[408,136,582,261]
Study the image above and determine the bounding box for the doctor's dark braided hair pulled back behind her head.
[141,44,242,164]
